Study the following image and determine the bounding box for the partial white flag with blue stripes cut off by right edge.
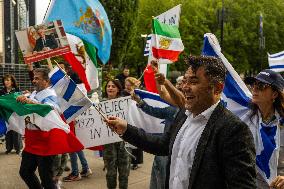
[268,51,284,72]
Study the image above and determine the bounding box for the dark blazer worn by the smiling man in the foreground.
[123,103,256,189]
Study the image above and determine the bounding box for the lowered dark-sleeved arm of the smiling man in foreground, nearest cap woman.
[221,119,256,189]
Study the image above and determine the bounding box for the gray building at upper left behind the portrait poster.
[0,0,35,90]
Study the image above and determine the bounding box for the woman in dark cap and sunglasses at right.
[241,69,284,189]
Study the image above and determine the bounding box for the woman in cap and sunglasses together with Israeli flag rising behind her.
[202,33,284,189]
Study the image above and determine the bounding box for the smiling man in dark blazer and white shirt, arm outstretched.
[106,56,256,189]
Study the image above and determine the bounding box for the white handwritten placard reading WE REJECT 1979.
[75,96,131,148]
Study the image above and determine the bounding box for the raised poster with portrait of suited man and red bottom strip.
[15,20,71,64]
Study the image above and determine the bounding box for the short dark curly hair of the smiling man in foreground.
[184,56,226,84]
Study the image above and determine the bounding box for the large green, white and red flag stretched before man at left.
[0,93,84,156]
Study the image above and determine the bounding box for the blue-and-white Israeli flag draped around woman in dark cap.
[202,33,280,184]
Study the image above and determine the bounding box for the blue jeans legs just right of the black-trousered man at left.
[69,150,89,175]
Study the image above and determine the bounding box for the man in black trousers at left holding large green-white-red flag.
[17,68,60,189]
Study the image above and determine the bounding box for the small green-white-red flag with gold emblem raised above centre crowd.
[151,19,184,63]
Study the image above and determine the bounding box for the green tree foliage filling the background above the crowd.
[102,0,284,75]
